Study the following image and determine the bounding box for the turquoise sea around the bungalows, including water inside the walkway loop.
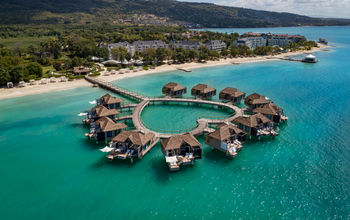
[0,27,350,219]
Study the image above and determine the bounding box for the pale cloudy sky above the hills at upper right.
[180,0,350,18]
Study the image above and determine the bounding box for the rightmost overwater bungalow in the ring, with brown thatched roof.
[253,102,288,123]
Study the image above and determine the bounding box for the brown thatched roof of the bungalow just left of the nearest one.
[113,130,155,146]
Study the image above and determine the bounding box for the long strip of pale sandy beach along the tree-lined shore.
[0,45,330,100]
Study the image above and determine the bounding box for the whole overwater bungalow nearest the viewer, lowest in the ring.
[161,133,202,171]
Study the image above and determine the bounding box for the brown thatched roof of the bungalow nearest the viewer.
[160,133,201,150]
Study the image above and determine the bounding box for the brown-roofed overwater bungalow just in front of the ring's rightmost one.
[233,113,278,137]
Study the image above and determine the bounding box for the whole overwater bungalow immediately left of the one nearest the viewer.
[107,130,159,160]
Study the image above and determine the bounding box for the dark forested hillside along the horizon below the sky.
[0,0,350,27]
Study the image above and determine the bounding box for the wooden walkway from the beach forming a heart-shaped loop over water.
[85,76,243,138]
